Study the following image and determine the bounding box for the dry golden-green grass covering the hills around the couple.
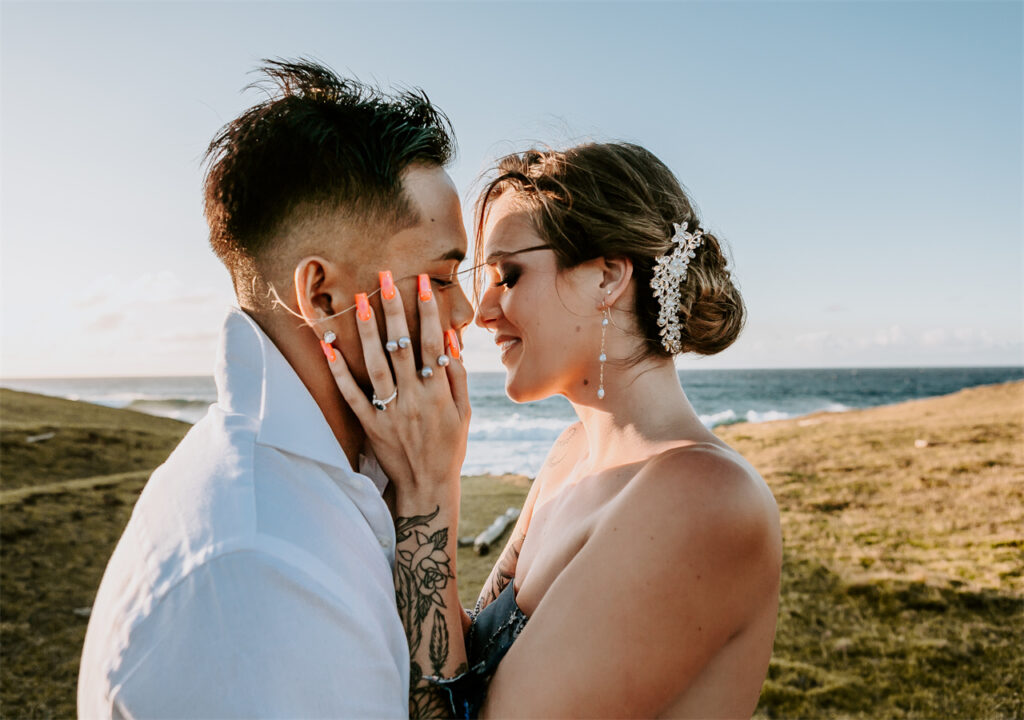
[0,383,1024,718]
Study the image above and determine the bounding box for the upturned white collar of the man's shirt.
[214,307,356,475]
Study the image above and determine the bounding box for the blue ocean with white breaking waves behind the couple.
[0,367,1024,477]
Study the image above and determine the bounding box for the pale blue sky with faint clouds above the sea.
[0,1,1024,377]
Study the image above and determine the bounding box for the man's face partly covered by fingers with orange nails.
[319,165,473,384]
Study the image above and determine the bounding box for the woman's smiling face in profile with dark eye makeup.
[475,192,601,403]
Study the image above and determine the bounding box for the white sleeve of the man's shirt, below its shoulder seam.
[112,550,409,718]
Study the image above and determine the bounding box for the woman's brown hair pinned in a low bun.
[474,142,746,357]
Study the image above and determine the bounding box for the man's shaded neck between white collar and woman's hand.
[246,310,366,471]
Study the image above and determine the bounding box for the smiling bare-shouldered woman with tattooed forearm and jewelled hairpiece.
[335,143,781,717]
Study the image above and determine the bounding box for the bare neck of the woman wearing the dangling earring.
[569,358,714,474]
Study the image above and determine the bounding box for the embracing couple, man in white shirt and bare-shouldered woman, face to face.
[78,60,781,720]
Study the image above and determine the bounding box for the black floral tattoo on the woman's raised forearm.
[394,507,465,718]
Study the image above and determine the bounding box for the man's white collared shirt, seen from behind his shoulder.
[78,308,409,720]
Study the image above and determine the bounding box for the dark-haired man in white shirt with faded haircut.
[78,61,472,720]
